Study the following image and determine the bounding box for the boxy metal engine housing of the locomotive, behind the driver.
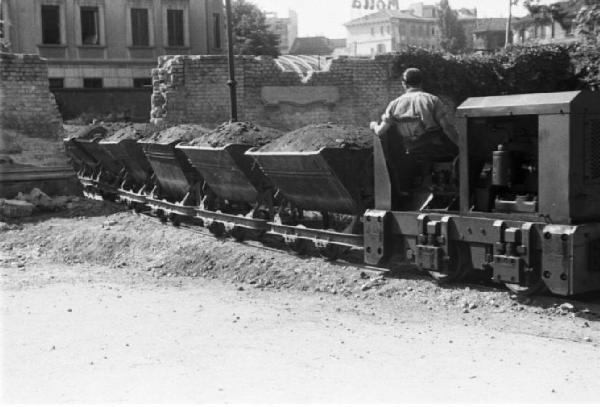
[457,91,600,224]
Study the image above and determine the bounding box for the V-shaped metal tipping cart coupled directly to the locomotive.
[246,148,372,257]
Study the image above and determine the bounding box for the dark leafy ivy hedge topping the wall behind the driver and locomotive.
[392,45,600,104]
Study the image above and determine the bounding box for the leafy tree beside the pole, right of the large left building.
[232,0,279,57]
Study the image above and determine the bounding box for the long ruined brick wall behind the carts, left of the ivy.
[151,56,402,130]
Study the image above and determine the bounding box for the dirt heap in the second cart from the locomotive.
[185,122,283,147]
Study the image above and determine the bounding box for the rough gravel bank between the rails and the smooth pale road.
[0,199,600,332]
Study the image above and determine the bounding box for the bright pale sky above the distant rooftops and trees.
[248,0,552,38]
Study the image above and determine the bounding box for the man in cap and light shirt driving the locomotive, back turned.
[370,68,458,162]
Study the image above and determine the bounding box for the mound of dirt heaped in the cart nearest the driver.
[259,123,373,152]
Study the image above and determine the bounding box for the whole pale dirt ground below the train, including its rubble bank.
[0,202,600,403]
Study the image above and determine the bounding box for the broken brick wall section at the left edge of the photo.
[0,53,62,138]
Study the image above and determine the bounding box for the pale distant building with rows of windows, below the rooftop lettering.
[345,3,477,56]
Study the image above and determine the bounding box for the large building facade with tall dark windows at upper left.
[2,0,226,88]
